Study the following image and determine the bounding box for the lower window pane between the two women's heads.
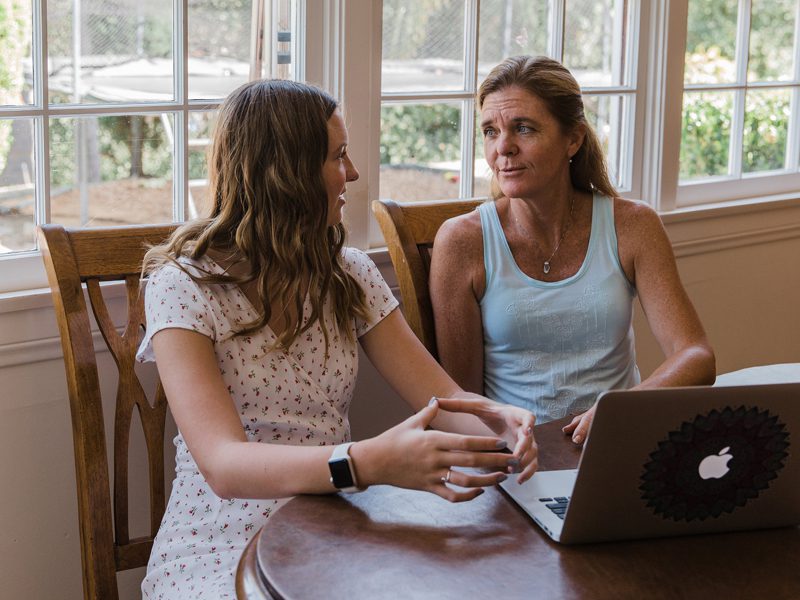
[380,104,461,201]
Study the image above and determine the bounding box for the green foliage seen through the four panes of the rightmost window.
[680,0,795,179]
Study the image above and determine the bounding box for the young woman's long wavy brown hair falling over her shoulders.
[143,80,368,354]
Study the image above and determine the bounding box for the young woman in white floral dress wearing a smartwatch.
[140,81,537,600]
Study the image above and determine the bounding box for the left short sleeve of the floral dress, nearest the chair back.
[136,265,216,362]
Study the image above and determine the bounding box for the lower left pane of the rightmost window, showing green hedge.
[680,92,733,179]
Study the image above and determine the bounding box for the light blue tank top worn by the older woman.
[478,194,641,423]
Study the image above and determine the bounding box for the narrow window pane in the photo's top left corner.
[0,2,33,106]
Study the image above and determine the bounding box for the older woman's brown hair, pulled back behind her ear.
[478,56,619,198]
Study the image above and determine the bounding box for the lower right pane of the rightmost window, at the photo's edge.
[742,90,791,173]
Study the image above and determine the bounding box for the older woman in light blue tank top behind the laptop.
[430,56,715,443]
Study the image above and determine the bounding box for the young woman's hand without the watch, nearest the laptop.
[438,394,539,483]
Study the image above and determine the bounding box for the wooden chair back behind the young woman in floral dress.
[38,225,175,600]
